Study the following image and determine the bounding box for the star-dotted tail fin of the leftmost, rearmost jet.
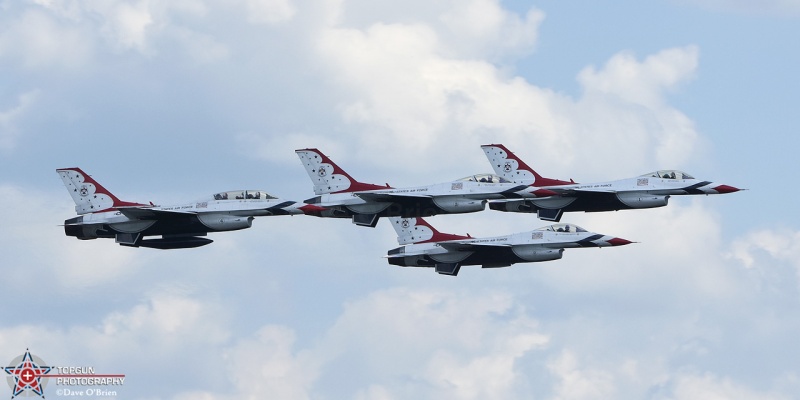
[56,168,147,214]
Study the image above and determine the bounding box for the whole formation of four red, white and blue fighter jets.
[57,144,740,275]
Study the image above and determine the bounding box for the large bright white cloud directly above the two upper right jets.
[317,5,700,179]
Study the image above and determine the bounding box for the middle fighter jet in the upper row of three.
[295,149,555,228]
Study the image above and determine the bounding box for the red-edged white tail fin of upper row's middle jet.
[294,149,389,194]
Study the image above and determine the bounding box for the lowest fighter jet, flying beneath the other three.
[386,218,633,276]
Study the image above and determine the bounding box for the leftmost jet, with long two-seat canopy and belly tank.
[56,168,322,249]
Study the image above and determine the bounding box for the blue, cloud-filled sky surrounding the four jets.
[0,0,800,400]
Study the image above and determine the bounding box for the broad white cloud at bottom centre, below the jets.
[161,288,548,399]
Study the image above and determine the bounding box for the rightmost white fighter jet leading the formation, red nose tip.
[481,144,742,222]
